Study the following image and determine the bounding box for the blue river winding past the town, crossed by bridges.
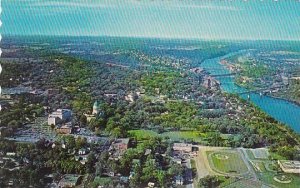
[200,51,300,133]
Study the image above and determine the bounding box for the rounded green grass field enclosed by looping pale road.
[207,151,248,174]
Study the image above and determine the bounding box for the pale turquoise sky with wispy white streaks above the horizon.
[0,0,300,41]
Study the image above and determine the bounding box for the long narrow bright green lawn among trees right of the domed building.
[129,130,204,142]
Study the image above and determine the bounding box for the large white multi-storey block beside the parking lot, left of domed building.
[48,109,72,125]
